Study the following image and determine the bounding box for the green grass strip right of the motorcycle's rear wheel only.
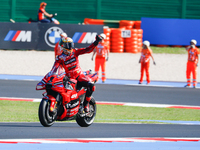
[96,105,200,122]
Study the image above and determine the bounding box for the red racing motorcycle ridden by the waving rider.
[36,67,98,127]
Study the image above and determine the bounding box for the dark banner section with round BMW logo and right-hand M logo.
[37,24,103,50]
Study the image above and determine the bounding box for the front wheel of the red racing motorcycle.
[38,99,57,127]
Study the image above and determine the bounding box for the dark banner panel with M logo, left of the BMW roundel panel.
[0,23,38,49]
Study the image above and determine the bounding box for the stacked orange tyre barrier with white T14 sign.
[84,18,143,53]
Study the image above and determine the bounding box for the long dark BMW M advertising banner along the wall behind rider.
[0,23,103,50]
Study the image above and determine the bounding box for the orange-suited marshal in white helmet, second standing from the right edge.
[139,41,156,84]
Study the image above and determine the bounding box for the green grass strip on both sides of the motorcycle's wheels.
[0,101,200,123]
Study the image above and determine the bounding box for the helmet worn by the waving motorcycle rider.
[60,37,74,54]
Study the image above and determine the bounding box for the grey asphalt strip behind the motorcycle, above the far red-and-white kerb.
[0,80,200,106]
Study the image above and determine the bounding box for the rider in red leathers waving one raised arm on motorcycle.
[52,35,103,113]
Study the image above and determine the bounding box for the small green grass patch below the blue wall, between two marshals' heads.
[151,46,187,54]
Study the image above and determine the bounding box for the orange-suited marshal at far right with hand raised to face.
[185,39,199,88]
